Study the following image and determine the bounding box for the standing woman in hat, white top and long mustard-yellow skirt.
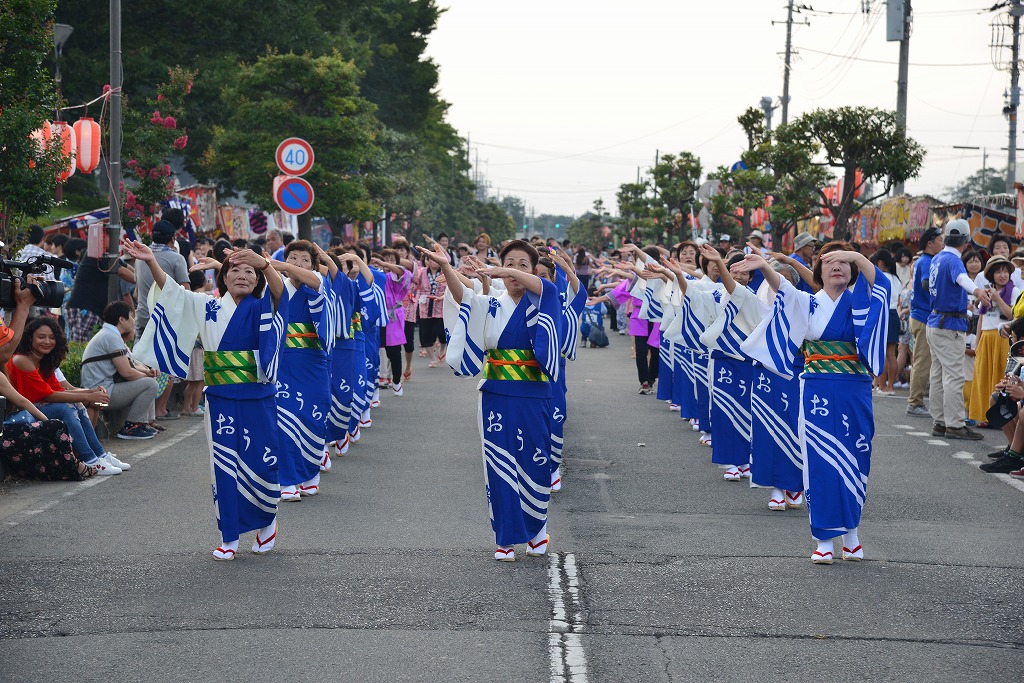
[968,256,1021,427]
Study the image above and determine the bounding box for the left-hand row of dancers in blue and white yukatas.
[123,240,403,560]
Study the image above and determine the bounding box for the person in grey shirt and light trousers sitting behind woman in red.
[82,301,158,439]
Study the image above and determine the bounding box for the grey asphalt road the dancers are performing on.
[0,334,1024,682]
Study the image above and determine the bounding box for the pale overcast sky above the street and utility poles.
[428,0,1024,215]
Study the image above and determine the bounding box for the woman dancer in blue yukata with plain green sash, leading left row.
[122,240,295,560]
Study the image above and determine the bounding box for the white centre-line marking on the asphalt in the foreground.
[548,553,587,683]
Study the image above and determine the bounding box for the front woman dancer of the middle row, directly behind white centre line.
[421,240,562,561]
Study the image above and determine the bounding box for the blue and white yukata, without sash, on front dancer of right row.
[743,268,890,541]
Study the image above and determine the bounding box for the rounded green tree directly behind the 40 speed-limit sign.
[205,52,385,239]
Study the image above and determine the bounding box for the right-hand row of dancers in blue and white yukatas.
[588,242,889,564]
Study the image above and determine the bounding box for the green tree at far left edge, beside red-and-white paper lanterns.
[0,0,66,244]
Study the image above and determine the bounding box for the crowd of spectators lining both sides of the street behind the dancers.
[9,209,1024,478]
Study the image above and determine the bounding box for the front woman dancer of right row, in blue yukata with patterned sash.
[733,242,890,564]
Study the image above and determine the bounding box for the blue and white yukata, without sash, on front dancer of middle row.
[444,280,563,547]
